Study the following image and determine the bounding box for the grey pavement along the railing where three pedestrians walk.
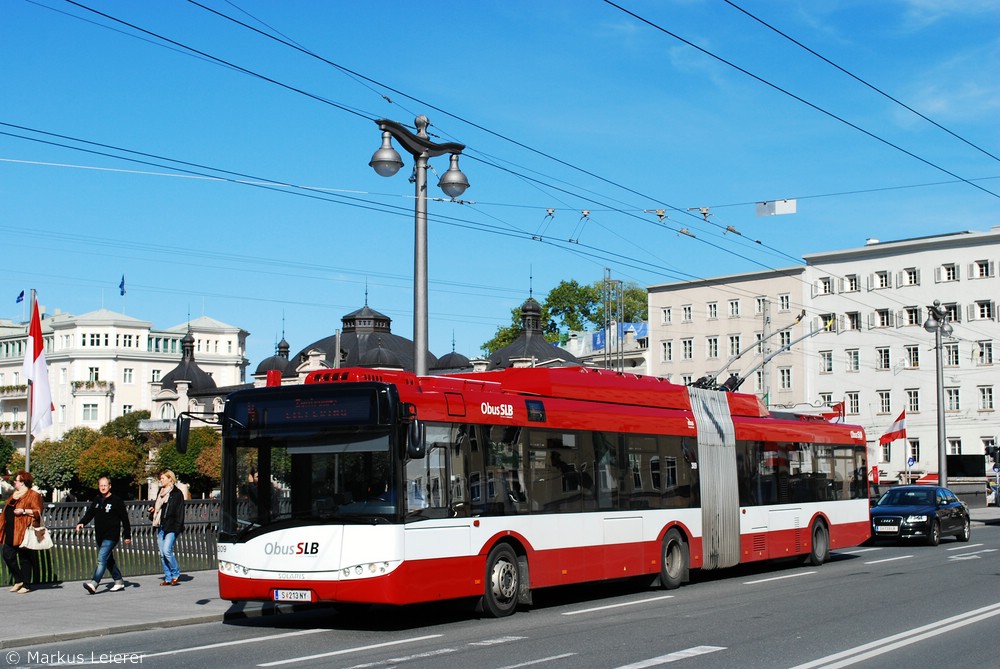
[7,506,1000,648]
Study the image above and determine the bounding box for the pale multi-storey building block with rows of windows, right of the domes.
[649,228,1000,482]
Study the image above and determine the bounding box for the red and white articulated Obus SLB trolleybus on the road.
[211,368,869,617]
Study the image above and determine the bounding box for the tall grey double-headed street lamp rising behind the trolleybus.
[368,114,469,376]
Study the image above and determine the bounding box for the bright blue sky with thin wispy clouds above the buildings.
[0,0,1000,366]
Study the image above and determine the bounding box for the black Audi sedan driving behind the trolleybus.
[871,485,972,546]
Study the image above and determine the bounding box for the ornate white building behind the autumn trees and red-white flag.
[0,309,248,449]
